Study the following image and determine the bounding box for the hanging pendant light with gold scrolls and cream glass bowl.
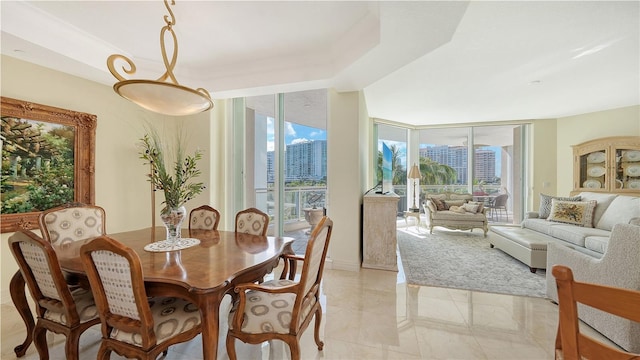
[107,0,213,116]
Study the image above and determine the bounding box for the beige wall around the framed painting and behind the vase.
[0,56,216,303]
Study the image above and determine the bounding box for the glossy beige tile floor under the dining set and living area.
[0,228,616,359]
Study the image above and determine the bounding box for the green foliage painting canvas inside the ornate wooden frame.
[1,116,75,214]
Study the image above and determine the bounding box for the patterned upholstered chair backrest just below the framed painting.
[38,203,106,244]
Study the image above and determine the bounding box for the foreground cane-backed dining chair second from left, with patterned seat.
[80,236,201,360]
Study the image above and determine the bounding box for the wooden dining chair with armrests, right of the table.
[226,216,333,360]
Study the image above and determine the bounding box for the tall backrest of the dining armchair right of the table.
[291,216,333,330]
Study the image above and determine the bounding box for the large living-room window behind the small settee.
[412,125,526,222]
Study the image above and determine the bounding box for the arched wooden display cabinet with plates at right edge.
[572,136,640,194]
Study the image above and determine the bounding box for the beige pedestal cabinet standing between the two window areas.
[362,194,400,271]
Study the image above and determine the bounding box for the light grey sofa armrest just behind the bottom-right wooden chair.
[546,223,640,301]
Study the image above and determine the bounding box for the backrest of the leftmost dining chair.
[9,230,80,325]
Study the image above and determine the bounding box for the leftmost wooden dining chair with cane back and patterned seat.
[9,230,100,360]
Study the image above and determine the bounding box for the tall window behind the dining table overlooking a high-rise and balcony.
[241,90,327,240]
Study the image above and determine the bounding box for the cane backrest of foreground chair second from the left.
[80,236,156,349]
